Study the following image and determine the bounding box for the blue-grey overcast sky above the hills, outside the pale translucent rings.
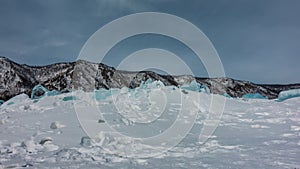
[0,0,300,83]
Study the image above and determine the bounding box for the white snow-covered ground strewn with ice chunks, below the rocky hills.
[0,83,300,169]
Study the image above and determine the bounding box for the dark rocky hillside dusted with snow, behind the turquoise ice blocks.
[0,57,300,100]
